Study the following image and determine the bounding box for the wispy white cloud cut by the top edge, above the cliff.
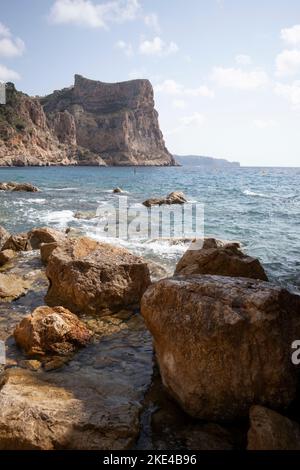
[49,0,141,28]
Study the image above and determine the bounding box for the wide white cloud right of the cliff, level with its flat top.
[212,67,269,90]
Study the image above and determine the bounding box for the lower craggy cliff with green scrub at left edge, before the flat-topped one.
[0,83,77,166]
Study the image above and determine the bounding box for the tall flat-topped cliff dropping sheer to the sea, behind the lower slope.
[41,75,174,166]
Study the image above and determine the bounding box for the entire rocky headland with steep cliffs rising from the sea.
[0,75,175,166]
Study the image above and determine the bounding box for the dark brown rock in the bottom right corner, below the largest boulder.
[247,406,300,450]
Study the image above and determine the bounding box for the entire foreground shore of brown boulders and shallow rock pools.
[0,189,300,450]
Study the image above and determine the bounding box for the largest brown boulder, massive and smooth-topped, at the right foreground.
[141,275,300,420]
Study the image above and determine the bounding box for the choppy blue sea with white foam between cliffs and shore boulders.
[0,167,300,292]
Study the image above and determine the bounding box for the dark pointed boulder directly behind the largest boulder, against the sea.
[175,238,268,281]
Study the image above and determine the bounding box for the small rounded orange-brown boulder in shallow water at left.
[14,307,91,356]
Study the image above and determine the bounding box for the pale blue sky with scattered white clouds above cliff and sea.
[0,0,300,167]
